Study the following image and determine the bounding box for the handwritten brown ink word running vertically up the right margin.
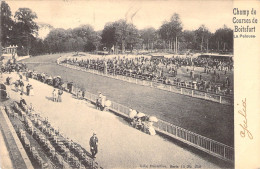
[238,98,253,140]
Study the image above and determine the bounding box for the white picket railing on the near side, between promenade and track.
[68,85,234,163]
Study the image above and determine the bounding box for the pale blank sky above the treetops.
[6,0,233,37]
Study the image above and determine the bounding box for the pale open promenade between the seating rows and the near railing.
[1,73,234,168]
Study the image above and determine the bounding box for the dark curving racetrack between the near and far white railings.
[18,54,234,146]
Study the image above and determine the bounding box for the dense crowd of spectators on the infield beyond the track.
[62,56,233,94]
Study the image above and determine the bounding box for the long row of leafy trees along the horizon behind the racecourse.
[1,1,233,55]
